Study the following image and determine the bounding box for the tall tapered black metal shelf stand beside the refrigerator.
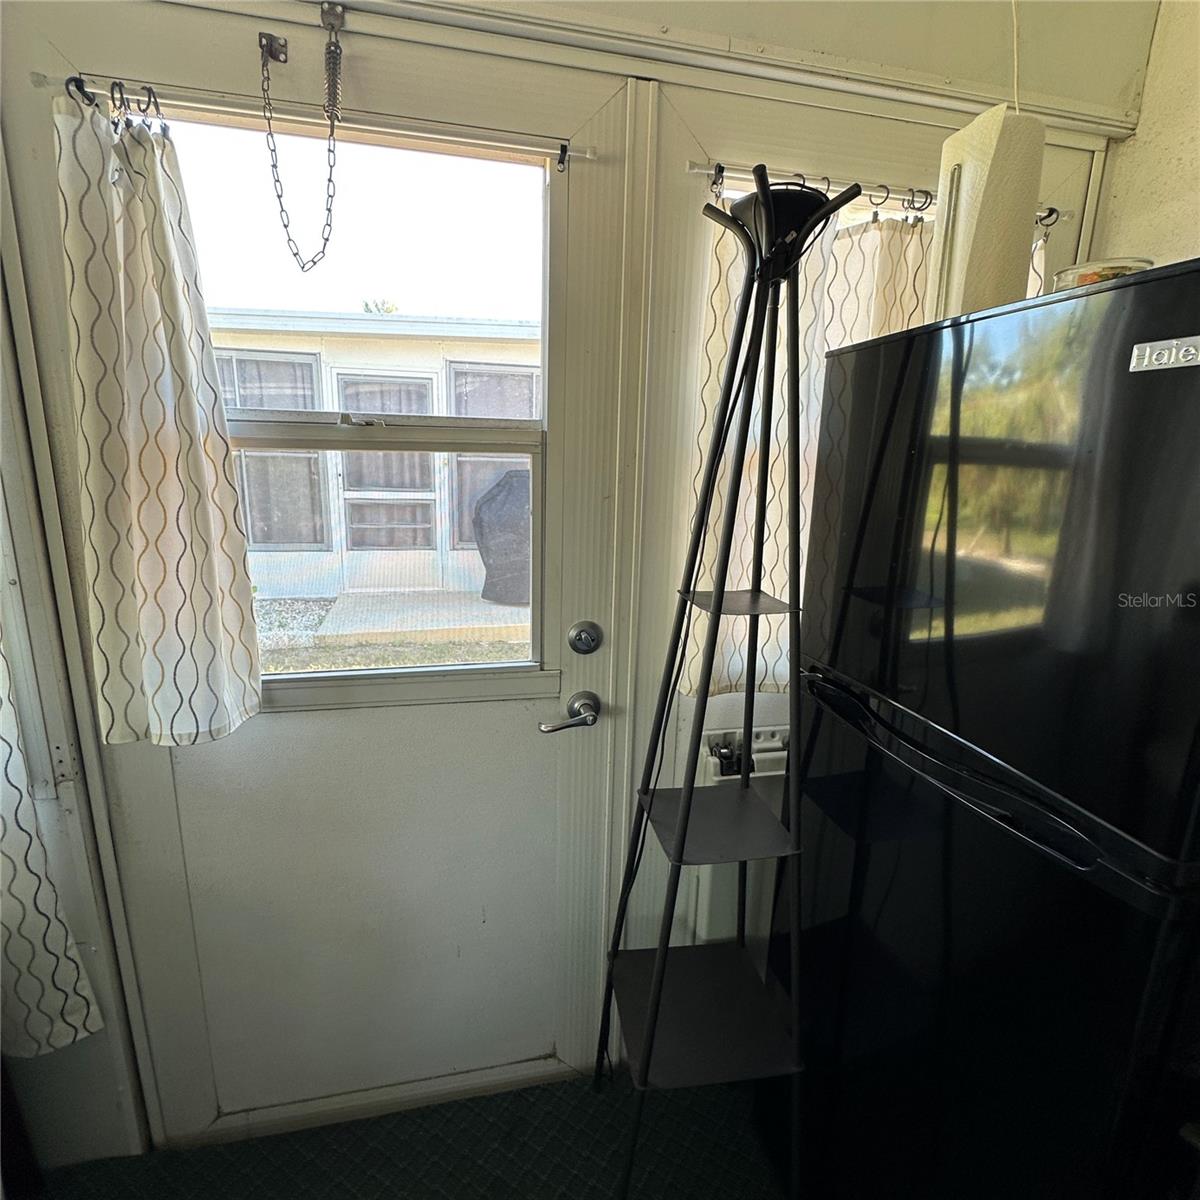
[595,164,862,1198]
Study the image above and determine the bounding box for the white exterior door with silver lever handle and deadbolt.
[6,5,641,1144]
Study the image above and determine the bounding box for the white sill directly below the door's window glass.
[263,662,560,713]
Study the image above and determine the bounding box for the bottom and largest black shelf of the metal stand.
[613,942,799,1088]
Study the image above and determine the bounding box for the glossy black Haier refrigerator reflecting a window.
[768,260,1200,1200]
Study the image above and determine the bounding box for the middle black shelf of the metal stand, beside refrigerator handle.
[638,775,796,865]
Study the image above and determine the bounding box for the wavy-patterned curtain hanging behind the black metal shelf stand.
[680,211,934,695]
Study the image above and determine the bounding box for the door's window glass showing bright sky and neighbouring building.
[172,122,546,674]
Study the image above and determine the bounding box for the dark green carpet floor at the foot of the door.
[39,1080,781,1200]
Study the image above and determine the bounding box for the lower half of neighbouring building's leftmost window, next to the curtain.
[239,450,329,550]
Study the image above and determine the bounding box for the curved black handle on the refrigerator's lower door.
[809,678,1103,871]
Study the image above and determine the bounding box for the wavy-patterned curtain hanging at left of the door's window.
[54,95,260,745]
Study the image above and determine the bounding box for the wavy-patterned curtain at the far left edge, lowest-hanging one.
[0,600,104,1058]
